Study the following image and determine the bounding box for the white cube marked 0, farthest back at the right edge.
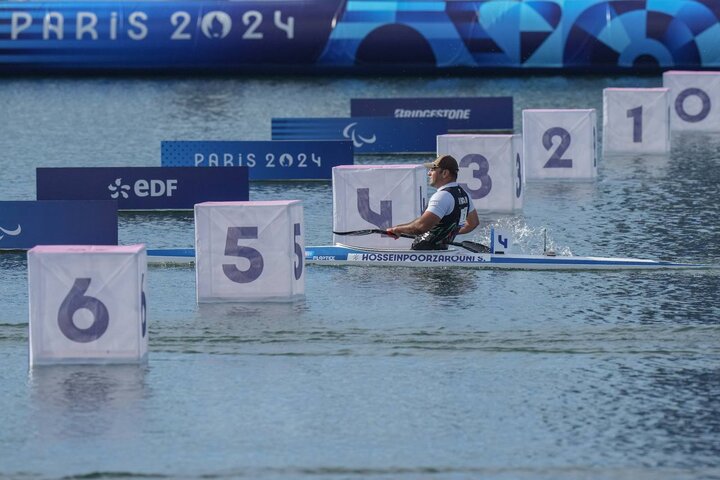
[663,70,720,132]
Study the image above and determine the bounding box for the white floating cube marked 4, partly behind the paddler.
[333,165,427,248]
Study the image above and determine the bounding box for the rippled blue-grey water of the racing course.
[0,76,720,479]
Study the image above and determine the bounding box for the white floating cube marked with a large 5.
[195,200,305,302]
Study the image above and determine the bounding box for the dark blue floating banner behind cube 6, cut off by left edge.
[0,200,118,250]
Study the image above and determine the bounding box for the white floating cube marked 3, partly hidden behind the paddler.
[437,134,525,213]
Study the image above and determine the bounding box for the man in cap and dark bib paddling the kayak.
[386,155,480,250]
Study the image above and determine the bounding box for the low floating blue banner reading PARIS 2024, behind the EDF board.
[160,140,353,181]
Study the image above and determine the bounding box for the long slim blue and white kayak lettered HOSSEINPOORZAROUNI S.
[147,248,717,270]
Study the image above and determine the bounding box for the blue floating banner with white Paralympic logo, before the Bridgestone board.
[272,117,448,153]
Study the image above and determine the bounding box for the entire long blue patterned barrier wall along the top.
[0,0,720,73]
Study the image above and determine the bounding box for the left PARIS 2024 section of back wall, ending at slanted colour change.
[0,0,344,72]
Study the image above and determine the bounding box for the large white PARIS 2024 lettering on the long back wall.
[0,8,295,41]
